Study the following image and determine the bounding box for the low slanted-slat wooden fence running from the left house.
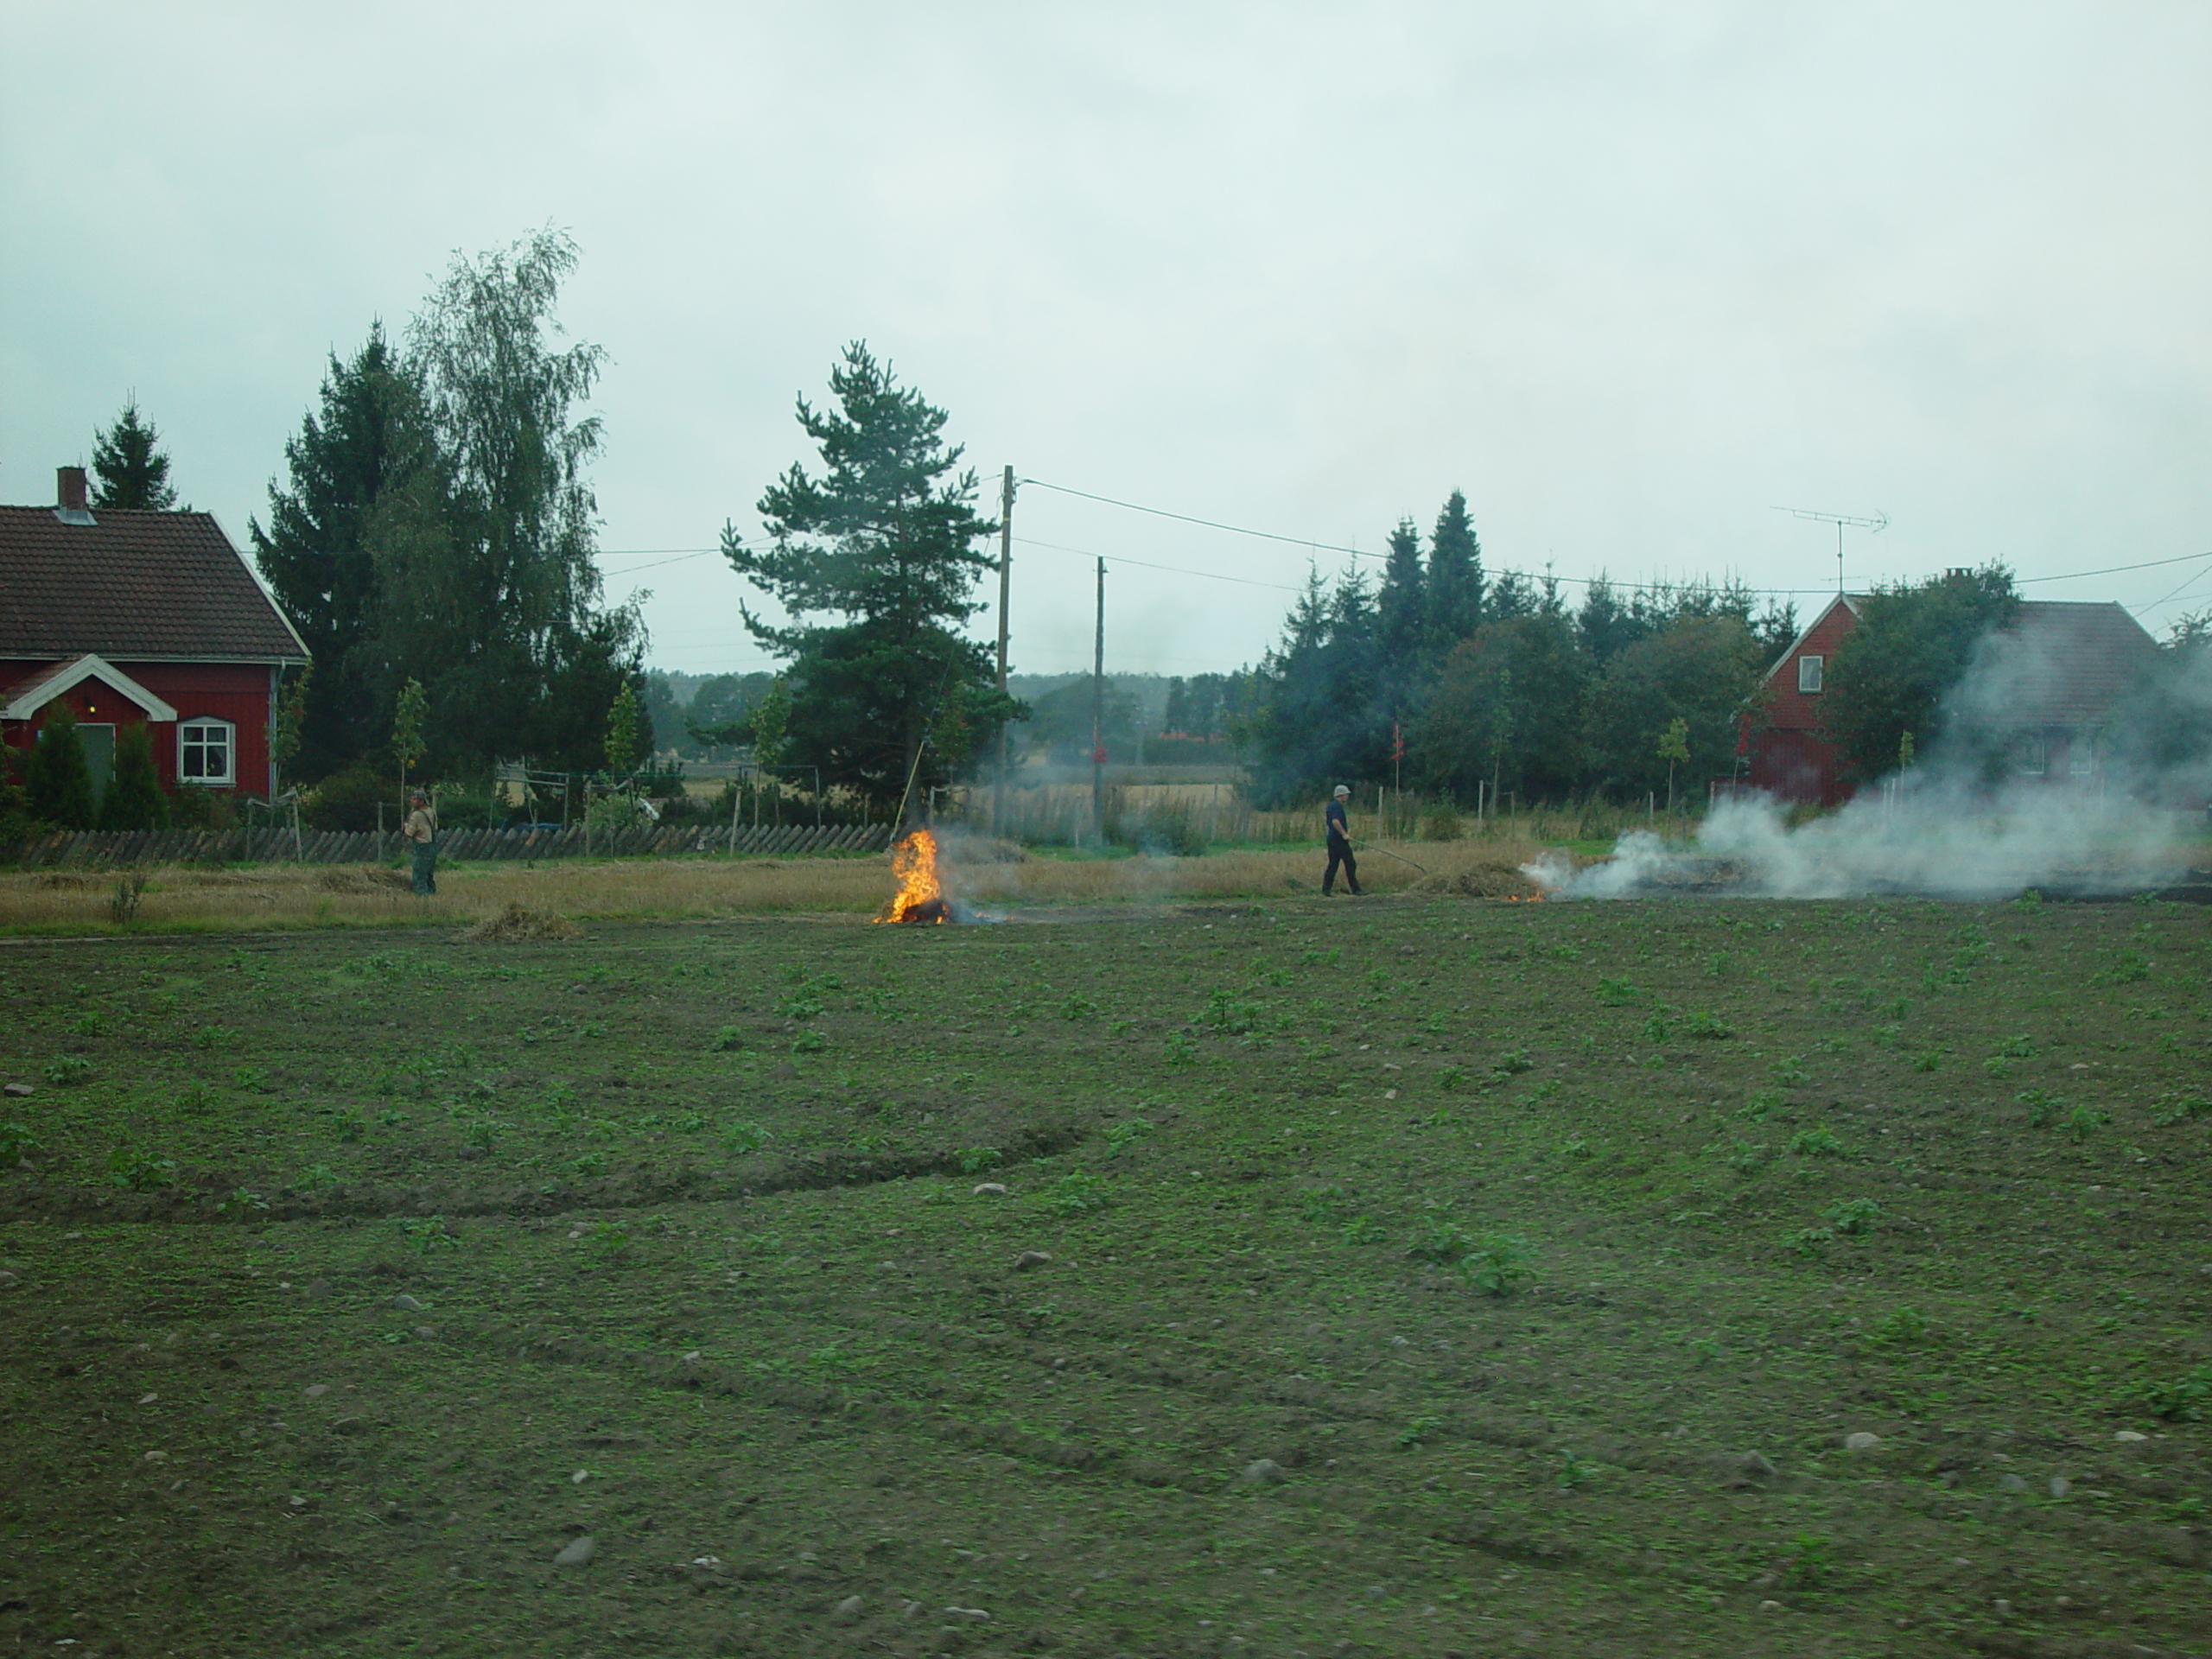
[0,823,892,869]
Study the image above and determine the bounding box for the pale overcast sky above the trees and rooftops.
[0,0,2212,675]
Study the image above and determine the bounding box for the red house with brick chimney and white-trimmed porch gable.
[0,467,308,797]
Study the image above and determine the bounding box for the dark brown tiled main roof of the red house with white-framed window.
[0,506,308,661]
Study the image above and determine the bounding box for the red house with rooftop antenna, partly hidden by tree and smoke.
[1747,593,2157,807]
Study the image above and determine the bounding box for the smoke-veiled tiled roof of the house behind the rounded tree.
[1964,600,2157,726]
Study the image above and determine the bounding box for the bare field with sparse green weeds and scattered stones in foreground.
[0,889,2212,1659]
